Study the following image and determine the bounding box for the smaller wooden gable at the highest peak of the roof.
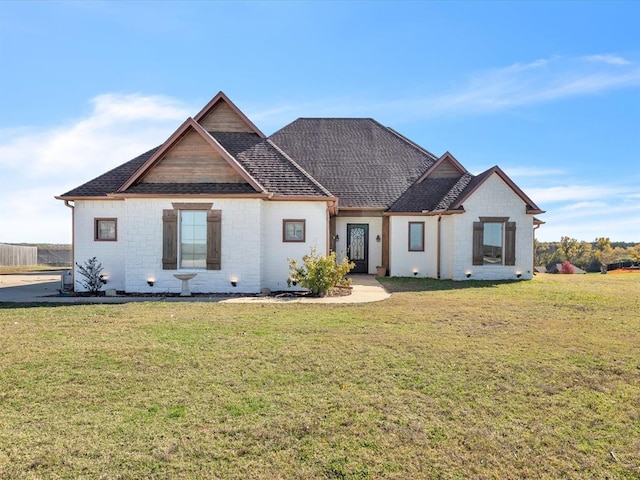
[194,92,265,138]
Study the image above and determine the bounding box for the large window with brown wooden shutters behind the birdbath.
[162,203,222,270]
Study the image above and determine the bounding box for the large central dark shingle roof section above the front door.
[269,118,437,208]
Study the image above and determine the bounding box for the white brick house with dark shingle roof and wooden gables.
[56,92,543,293]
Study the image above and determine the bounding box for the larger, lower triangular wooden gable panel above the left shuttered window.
[142,130,247,183]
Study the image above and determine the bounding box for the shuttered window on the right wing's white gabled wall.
[473,217,516,265]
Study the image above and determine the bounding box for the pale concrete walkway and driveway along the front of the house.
[0,272,391,304]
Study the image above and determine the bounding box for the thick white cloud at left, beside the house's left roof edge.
[0,94,190,243]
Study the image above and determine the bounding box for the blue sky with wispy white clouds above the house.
[0,1,640,243]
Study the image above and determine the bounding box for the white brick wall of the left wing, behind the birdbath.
[75,198,328,293]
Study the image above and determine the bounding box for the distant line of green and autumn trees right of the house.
[534,237,640,272]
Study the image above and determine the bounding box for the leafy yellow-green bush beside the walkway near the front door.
[287,247,355,297]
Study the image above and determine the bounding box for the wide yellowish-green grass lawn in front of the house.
[0,274,640,479]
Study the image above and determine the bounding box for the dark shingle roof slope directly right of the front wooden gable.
[209,132,332,197]
